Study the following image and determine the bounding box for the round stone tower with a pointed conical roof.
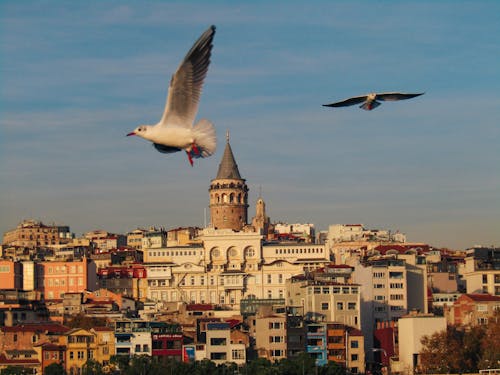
[208,132,248,231]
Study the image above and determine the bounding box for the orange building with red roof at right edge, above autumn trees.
[445,294,500,326]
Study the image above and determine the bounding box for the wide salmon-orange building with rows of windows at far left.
[35,257,97,300]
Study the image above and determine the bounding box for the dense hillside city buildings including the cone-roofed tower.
[0,139,500,374]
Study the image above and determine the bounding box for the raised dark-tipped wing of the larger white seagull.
[160,25,215,128]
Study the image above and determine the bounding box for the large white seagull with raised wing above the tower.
[127,25,217,166]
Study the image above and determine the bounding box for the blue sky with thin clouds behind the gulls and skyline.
[0,0,500,249]
